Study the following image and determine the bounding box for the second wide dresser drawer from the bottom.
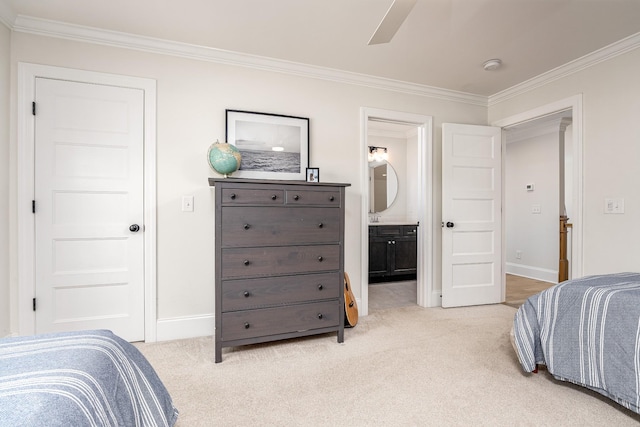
[222,272,343,312]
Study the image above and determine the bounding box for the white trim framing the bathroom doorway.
[358,107,439,316]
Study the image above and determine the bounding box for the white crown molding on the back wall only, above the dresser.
[13,15,487,107]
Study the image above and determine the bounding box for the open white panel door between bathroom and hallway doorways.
[442,123,502,307]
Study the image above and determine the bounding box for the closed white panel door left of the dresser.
[35,78,144,341]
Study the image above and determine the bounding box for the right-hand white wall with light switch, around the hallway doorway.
[489,49,640,274]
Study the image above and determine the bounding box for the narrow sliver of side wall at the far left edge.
[0,23,11,337]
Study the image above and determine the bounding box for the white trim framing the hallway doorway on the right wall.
[491,94,583,280]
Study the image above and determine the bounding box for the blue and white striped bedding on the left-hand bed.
[0,330,178,427]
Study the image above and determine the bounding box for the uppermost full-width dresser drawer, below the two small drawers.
[221,206,341,247]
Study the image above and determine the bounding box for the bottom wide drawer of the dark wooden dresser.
[216,300,340,341]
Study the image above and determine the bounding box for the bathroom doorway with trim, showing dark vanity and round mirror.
[359,109,433,315]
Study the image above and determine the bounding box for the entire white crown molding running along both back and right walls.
[8,12,640,107]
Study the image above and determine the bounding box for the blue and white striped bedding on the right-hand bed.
[513,273,640,413]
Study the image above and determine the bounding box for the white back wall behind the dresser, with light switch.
[8,32,487,331]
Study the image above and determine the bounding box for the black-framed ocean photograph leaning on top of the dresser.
[225,110,309,181]
